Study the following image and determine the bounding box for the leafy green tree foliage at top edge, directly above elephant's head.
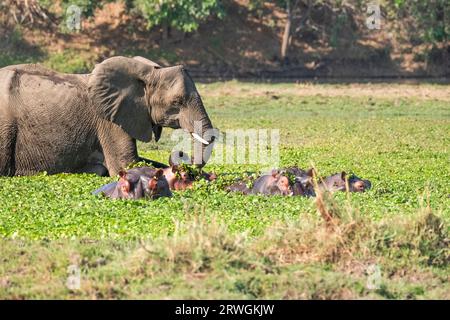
[134,0,224,32]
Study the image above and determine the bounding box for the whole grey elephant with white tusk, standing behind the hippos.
[0,56,214,176]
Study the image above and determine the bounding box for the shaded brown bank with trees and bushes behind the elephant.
[0,0,450,80]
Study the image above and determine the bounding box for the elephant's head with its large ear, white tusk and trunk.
[88,56,214,165]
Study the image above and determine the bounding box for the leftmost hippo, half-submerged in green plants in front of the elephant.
[93,167,172,199]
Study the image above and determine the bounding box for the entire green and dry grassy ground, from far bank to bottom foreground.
[0,82,450,299]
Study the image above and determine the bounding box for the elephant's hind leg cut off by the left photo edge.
[0,122,16,176]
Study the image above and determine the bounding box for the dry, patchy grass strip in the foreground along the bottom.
[0,213,450,299]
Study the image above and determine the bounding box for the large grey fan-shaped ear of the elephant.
[88,57,155,142]
